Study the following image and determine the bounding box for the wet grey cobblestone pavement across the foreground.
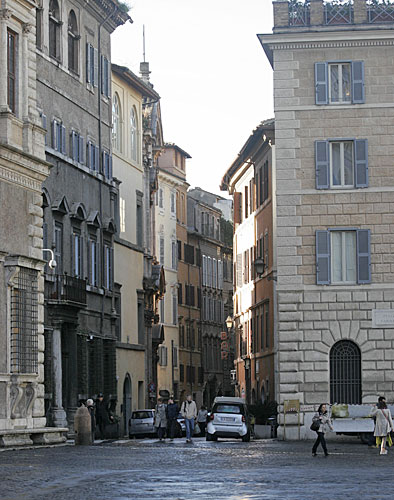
[0,439,394,500]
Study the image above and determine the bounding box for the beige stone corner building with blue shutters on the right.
[259,0,394,437]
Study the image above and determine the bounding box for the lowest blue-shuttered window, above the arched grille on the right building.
[316,229,371,285]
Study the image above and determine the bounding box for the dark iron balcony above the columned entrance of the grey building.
[45,274,86,307]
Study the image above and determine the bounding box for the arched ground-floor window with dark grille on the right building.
[330,340,361,404]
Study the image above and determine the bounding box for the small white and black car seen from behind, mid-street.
[206,397,251,442]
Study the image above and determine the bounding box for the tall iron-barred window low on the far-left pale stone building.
[11,268,38,373]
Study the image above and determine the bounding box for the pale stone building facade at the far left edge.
[0,1,67,447]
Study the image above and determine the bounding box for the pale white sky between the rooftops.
[111,0,273,196]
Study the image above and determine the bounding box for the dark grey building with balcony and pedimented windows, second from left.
[36,0,130,428]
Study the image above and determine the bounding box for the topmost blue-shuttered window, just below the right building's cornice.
[315,61,365,105]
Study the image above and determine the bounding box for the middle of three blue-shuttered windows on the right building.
[315,139,368,189]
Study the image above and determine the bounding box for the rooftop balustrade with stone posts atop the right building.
[273,0,394,31]
